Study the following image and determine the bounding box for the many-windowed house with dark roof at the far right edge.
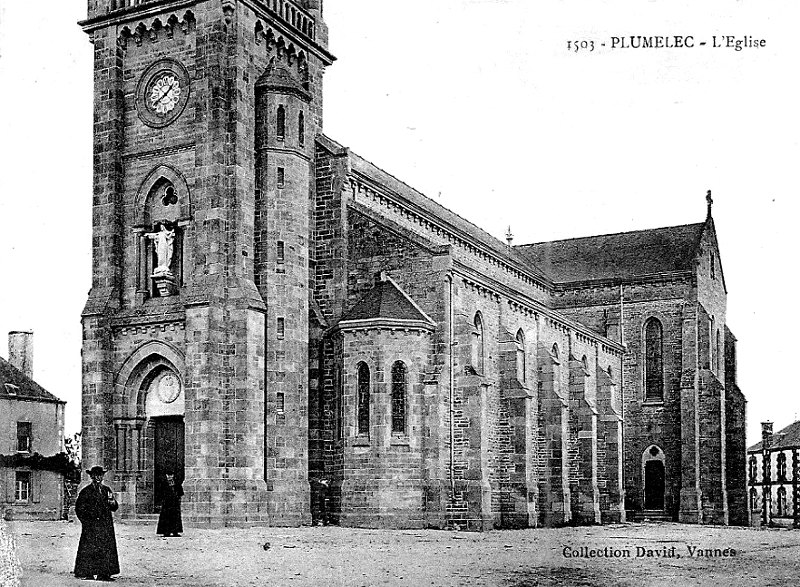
[747,421,800,526]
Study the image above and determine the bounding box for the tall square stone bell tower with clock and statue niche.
[81,0,334,526]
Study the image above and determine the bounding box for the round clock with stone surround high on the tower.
[136,59,189,128]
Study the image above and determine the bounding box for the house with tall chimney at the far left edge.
[0,332,66,520]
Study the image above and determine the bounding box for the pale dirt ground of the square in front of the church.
[11,522,800,587]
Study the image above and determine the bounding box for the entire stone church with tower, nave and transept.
[81,0,747,530]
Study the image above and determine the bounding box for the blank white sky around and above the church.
[0,0,800,444]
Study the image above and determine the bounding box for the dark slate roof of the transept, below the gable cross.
[514,222,705,283]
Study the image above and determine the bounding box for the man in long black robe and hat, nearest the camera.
[75,467,119,581]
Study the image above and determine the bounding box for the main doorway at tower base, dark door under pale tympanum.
[145,369,185,513]
